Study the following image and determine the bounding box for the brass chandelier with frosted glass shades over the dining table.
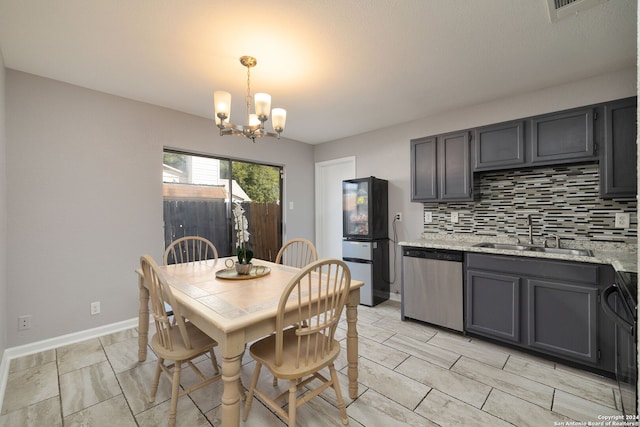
[213,56,287,142]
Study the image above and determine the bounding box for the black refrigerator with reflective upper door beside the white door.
[342,176,390,306]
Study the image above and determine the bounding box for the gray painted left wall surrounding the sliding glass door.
[0,70,314,347]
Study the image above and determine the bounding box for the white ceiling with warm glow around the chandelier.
[0,0,637,144]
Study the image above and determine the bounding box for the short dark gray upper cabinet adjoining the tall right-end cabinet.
[529,107,597,165]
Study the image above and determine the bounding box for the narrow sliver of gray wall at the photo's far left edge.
[0,51,7,355]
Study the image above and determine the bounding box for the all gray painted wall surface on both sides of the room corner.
[0,69,636,351]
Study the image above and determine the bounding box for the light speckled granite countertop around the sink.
[399,233,638,273]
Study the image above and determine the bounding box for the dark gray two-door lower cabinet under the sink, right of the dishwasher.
[464,253,615,372]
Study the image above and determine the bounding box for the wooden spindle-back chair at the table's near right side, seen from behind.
[243,259,351,426]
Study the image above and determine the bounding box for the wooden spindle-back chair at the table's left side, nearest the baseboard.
[140,255,220,427]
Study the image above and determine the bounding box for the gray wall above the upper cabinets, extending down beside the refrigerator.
[314,68,636,298]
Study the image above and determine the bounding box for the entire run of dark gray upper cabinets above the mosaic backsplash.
[411,97,637,202]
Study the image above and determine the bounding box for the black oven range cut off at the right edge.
[601,272,638,416]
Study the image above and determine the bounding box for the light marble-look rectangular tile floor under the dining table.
[0,301,632,427]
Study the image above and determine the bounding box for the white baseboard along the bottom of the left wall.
[0,317,138,414]
